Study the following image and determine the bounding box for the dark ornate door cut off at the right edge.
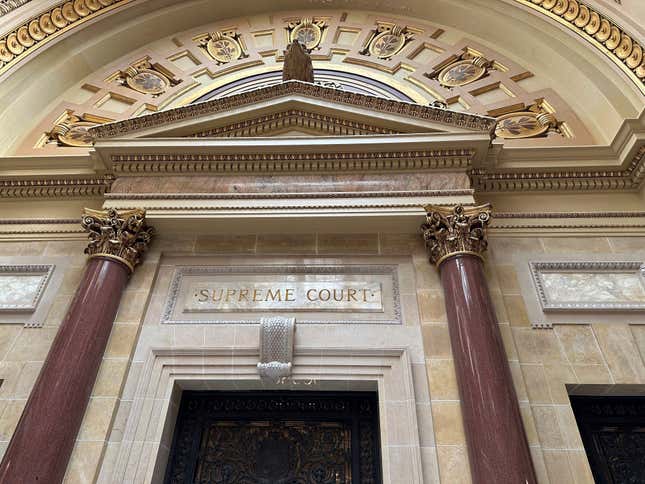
[571,396,645,484]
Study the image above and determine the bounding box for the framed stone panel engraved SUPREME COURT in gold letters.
[161,264,401,323]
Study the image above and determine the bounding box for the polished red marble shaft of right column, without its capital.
[440,254,537,484]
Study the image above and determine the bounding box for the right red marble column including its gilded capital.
[422,205,537,484]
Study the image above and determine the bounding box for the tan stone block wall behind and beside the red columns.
[0,234,645,484]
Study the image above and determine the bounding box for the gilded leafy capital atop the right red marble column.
[421,203,491,267]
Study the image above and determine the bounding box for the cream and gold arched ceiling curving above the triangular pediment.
[0,0,644,154]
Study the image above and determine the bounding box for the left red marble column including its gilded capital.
[0,211,151,484]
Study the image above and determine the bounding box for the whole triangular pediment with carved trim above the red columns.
[91,81,495,141]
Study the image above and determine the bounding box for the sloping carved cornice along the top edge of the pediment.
[89,80,496,140]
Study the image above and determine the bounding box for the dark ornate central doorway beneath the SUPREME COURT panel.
[165,391,381,484]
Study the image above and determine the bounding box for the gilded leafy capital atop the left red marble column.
[81,208,154,272]
